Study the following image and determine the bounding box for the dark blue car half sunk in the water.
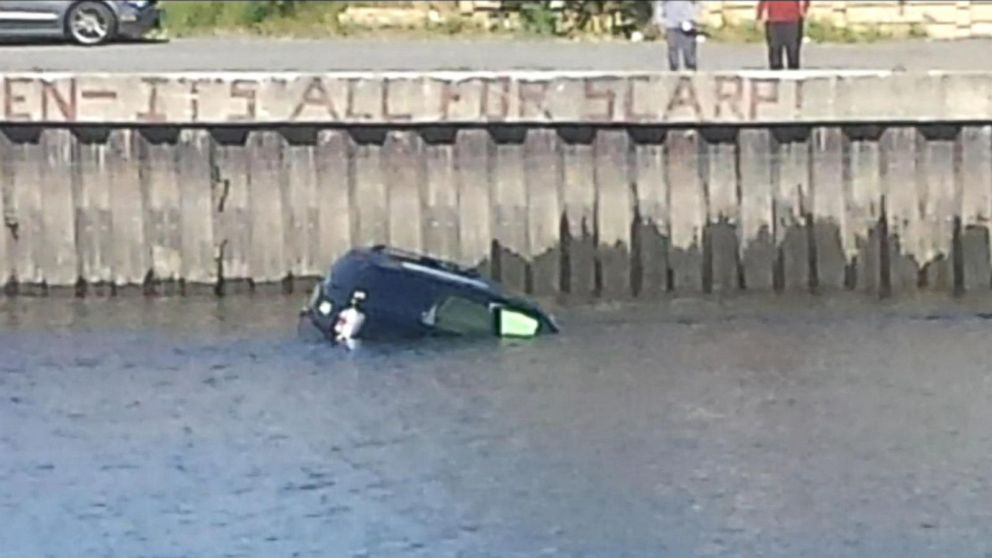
[300,246,559,344]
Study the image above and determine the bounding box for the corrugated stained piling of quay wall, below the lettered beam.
[0,120,992,299]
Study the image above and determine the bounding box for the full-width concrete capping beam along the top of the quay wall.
[0,71,992,126]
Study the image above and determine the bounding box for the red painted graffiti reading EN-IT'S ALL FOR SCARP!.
[0,74,816,124]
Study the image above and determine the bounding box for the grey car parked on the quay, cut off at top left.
[0,0,161,46]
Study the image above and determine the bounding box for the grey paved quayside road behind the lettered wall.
[0,38,992,72]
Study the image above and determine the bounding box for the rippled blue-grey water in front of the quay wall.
[0,296,992,558]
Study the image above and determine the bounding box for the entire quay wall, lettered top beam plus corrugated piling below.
[0,72,992,298]
